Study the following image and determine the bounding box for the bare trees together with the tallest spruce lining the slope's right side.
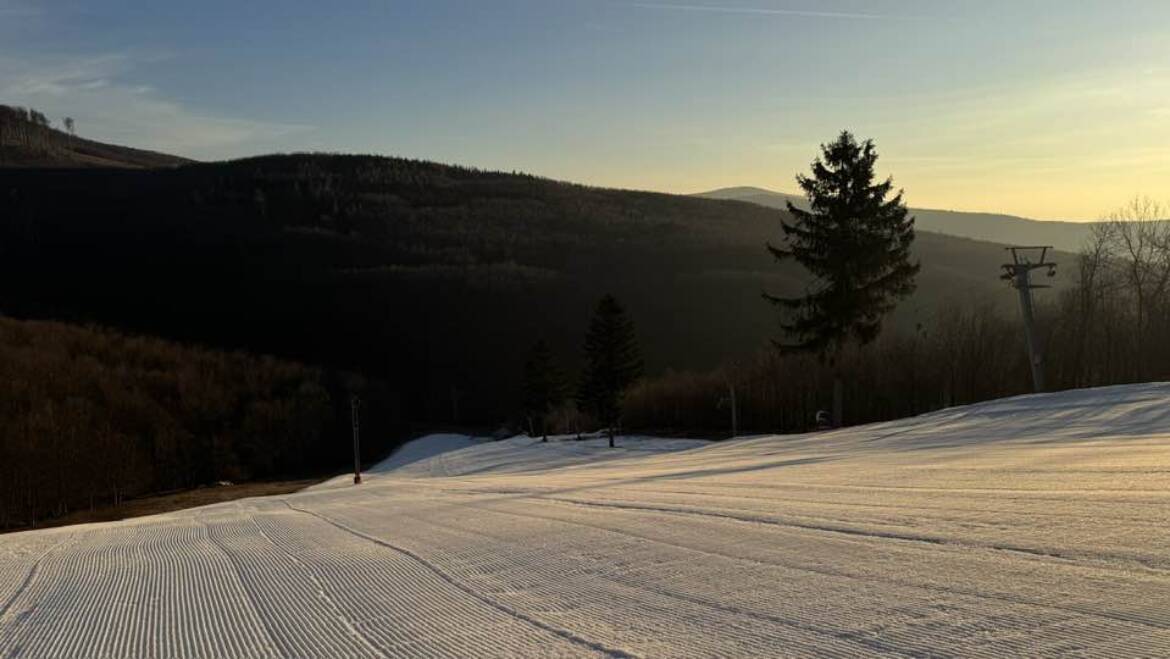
[525,132,1170,437]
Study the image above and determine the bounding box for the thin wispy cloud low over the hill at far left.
[0,52,311,158]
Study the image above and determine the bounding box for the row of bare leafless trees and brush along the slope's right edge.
[624,193,1170,435]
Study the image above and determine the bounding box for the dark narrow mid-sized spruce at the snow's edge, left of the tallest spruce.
[578,295,642,448]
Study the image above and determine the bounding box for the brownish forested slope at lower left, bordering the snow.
[0,317,407,529]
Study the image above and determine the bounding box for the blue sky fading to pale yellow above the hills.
[0,0,1170,220]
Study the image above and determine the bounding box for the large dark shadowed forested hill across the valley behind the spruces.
[0,156,1062,423]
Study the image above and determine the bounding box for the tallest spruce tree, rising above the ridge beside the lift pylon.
[765,131,918,426]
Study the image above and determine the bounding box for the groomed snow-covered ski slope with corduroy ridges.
[0,384,1170,657]
